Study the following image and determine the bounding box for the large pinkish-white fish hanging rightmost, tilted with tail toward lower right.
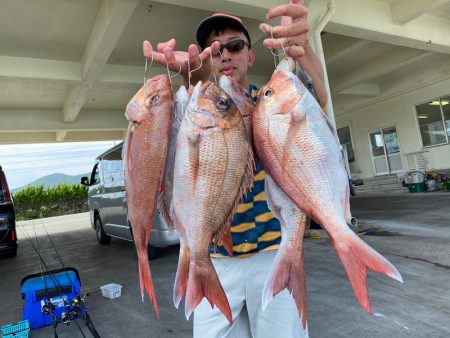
[253,60,402,313]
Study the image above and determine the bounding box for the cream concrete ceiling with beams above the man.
[0,0,450,143]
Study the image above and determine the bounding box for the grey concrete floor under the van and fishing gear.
[0,193,450,338]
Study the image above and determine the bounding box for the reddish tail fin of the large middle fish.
[185,259,233,324]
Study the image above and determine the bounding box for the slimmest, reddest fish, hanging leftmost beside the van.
[124,75,173,318]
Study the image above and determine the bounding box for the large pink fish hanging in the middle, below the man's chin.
[173,81,254,323]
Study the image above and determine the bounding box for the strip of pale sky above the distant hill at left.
[0,141,120,189]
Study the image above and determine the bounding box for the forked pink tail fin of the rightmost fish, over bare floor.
[333,232,403,313]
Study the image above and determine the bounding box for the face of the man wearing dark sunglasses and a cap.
[206,28,255,88]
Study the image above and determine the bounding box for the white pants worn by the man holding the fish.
[194,250,308,338]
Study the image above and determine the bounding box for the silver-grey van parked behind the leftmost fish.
[81,142,180,259]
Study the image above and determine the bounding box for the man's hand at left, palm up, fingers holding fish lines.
[143,39,220,88]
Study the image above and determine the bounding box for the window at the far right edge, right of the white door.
[416,98,449,147]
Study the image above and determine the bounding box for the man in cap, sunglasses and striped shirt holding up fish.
[144,0,326,338]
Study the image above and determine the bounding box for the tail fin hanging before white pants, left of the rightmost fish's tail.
[262,244,308,330]
